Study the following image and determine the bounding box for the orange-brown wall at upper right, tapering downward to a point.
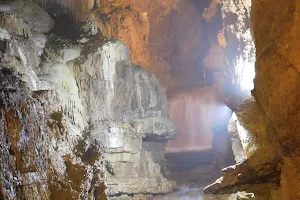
[252,1,300,153]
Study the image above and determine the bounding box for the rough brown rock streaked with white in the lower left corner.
[0,68,103,199]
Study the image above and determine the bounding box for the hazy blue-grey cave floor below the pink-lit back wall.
[158,149,227,200]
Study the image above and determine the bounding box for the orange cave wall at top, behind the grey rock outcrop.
[35,0,209,92]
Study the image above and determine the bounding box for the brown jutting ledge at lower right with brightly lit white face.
[204,99,282,196]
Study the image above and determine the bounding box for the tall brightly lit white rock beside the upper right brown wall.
[220,0,256,104]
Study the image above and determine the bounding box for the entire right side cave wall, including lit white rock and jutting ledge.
[205,0,300,200]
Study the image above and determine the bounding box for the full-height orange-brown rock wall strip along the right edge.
[252,0,300,199]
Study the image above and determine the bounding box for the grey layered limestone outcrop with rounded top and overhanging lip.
[75,41,177,196]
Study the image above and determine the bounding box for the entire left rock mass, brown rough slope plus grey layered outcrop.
[0,1,177,199]
